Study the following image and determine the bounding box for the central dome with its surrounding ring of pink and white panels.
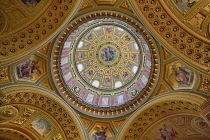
[60,18,152,107]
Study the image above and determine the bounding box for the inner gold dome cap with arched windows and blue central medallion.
[71,24,143,91]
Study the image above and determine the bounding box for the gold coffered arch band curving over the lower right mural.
[116,92,206,140]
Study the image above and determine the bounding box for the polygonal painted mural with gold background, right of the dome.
[167,62,195,89]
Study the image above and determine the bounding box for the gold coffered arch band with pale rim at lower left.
[2,85,86,139]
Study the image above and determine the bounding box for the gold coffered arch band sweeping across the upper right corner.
[129,0,210,72]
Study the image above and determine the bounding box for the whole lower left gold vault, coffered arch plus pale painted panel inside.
[0,85,87,140]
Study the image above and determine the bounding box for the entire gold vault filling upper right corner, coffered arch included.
[129,0,210,71]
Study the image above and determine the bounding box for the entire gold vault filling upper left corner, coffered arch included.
[0,0,82,68]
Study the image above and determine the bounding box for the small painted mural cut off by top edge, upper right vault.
[173,0,199,11]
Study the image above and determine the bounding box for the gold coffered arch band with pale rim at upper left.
[0,0,83,65]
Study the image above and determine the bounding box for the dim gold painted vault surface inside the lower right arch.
[140,115,210,140]
